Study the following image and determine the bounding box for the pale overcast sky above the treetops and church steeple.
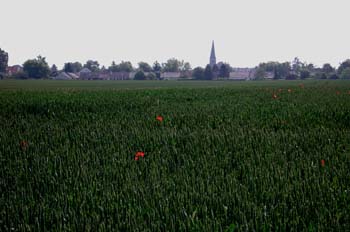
[0,0,350,68]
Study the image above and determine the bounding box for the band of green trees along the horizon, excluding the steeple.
[0,48,350,80]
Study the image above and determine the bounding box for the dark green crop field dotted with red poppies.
[0,80,350,231]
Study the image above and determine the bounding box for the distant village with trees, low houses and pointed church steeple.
[0,41,350,81]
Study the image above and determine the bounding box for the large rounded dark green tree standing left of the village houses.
[23,56,50,79]
